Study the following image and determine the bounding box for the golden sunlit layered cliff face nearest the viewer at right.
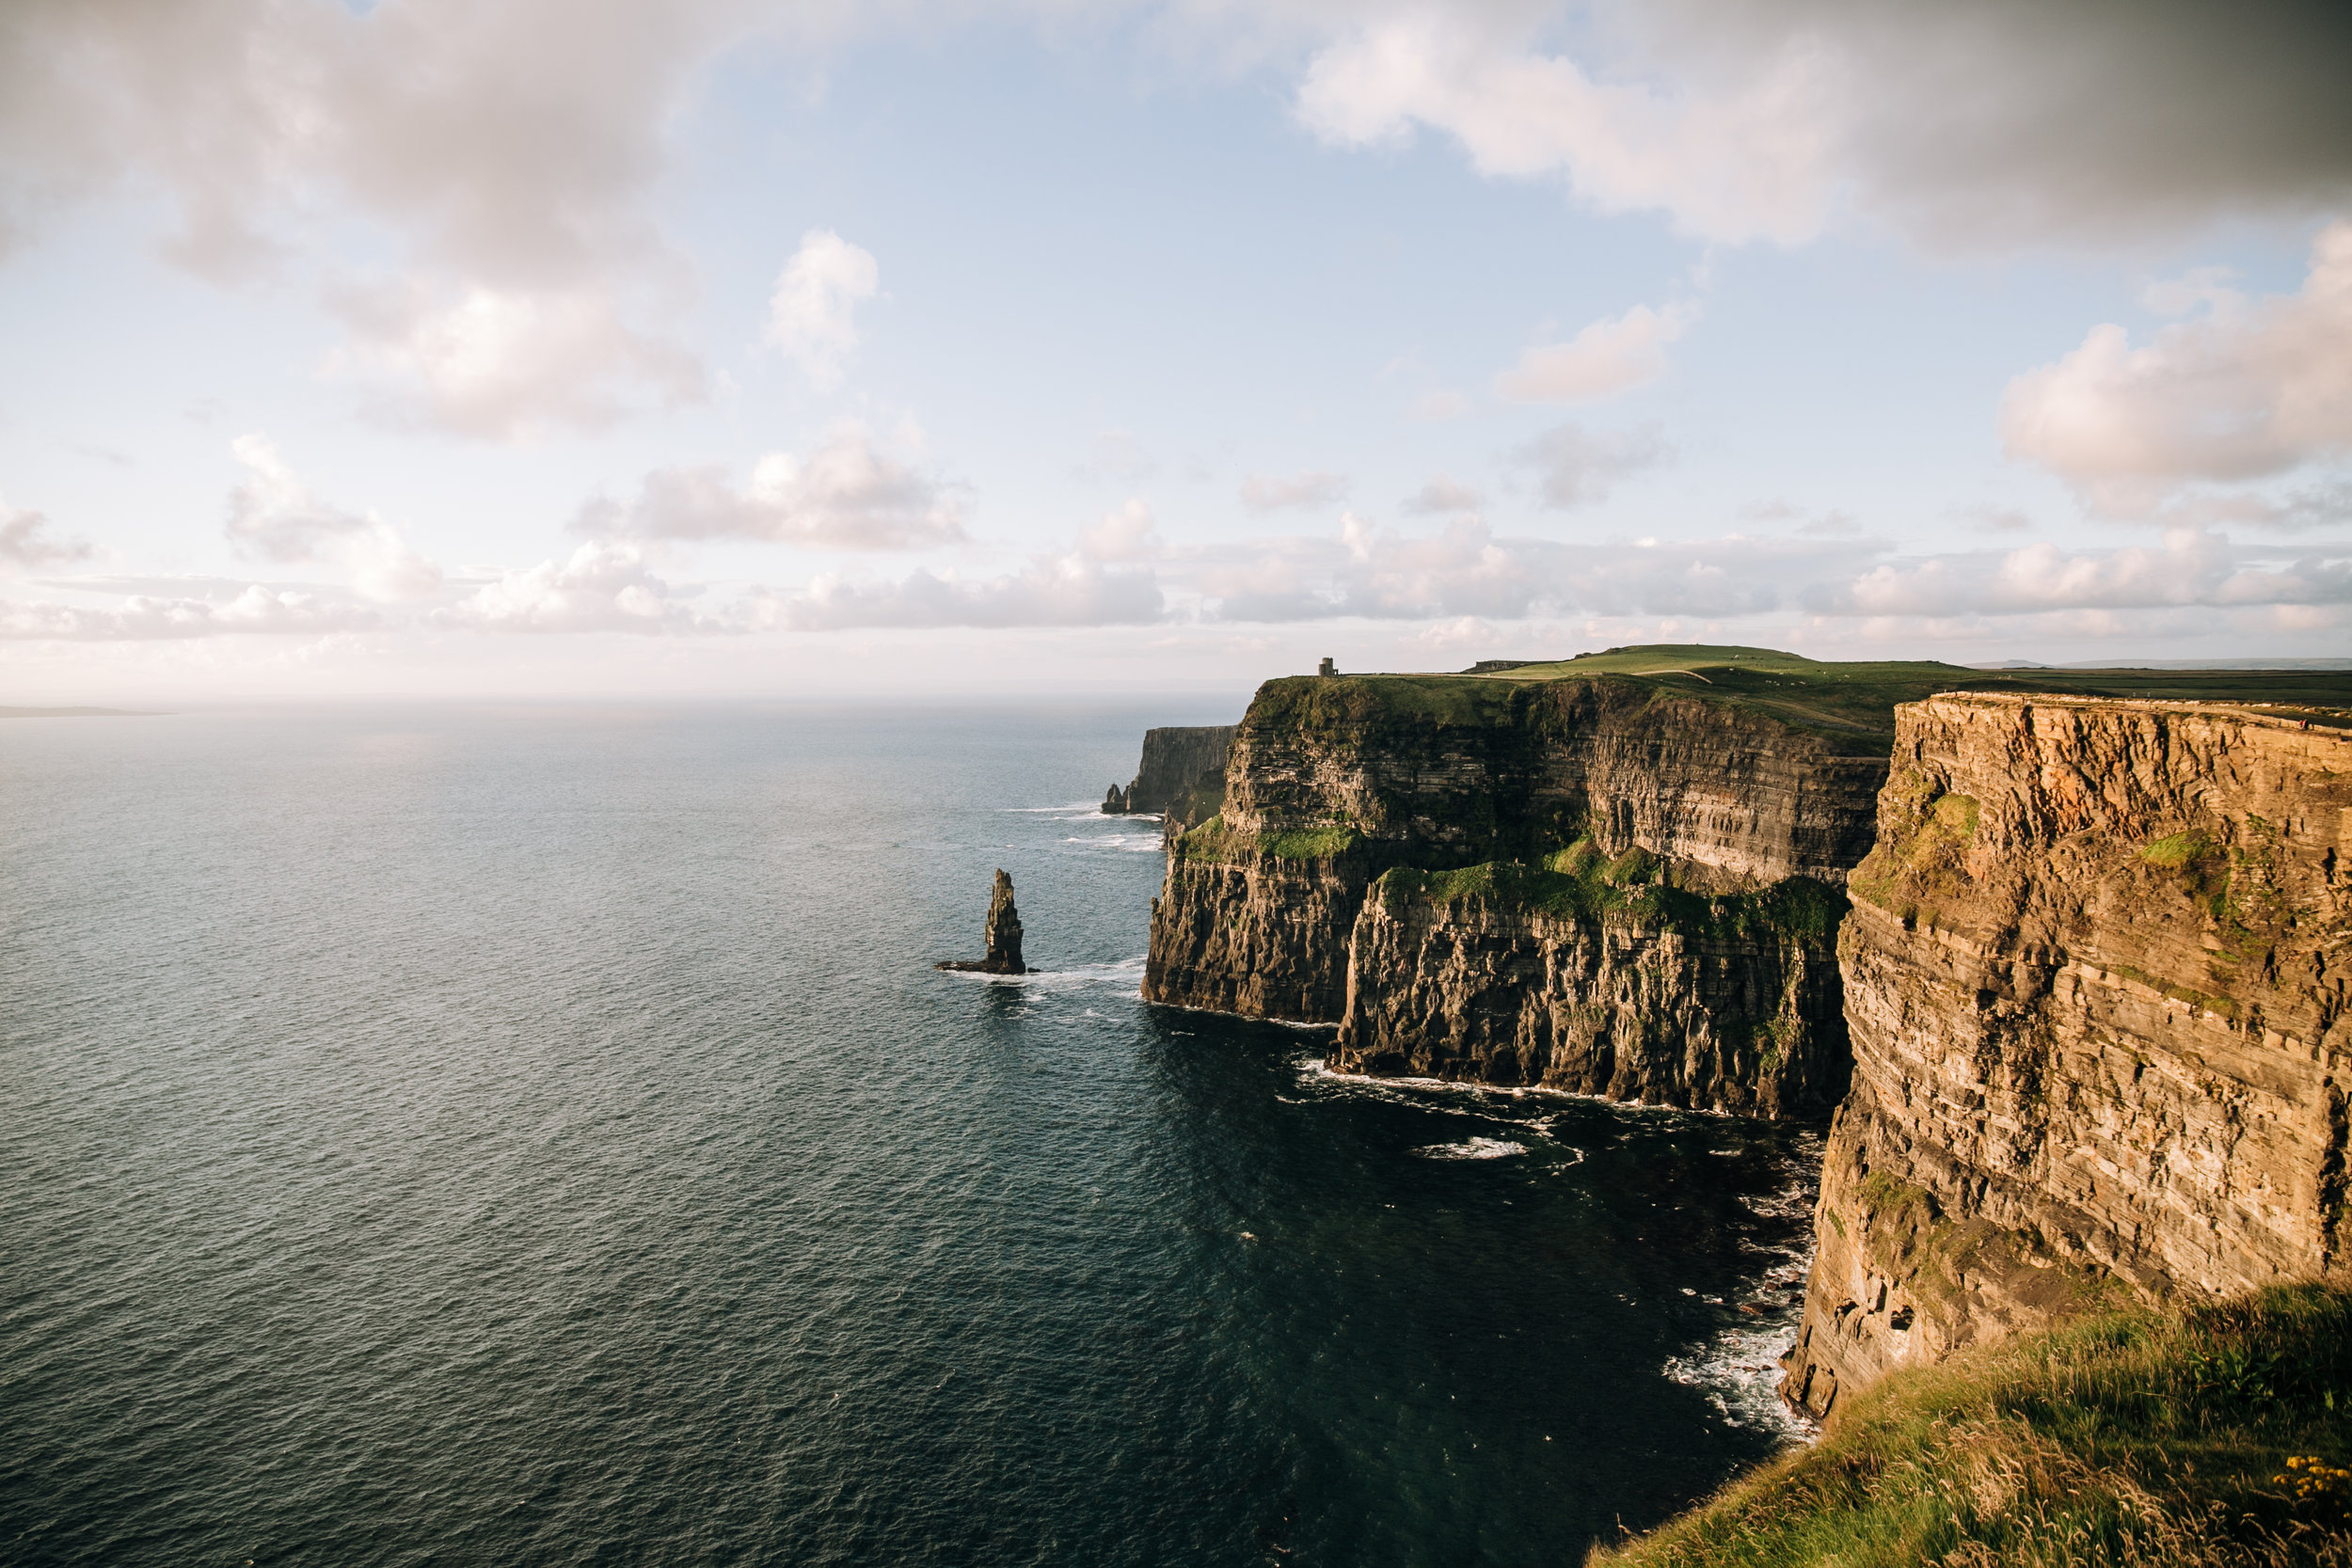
[1786,696,2352,1413]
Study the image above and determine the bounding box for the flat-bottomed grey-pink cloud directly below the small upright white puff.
[577,423,964,550]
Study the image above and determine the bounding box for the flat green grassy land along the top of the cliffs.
[1279,641,2352,752]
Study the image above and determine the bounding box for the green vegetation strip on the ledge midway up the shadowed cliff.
[1378,839,1847,942]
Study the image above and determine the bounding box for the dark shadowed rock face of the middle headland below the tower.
[1143,677,1886,1115]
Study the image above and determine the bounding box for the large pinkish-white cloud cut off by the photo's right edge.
[2002,221,2352,515]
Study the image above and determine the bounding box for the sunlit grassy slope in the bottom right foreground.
[1590,1286,2352,1568]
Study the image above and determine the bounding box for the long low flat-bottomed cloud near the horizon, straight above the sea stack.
[757,555,1167,632]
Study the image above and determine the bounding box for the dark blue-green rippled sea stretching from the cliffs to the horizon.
[0,703,1819,1566]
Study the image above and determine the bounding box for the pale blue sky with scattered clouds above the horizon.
[0,0,2352,703]
